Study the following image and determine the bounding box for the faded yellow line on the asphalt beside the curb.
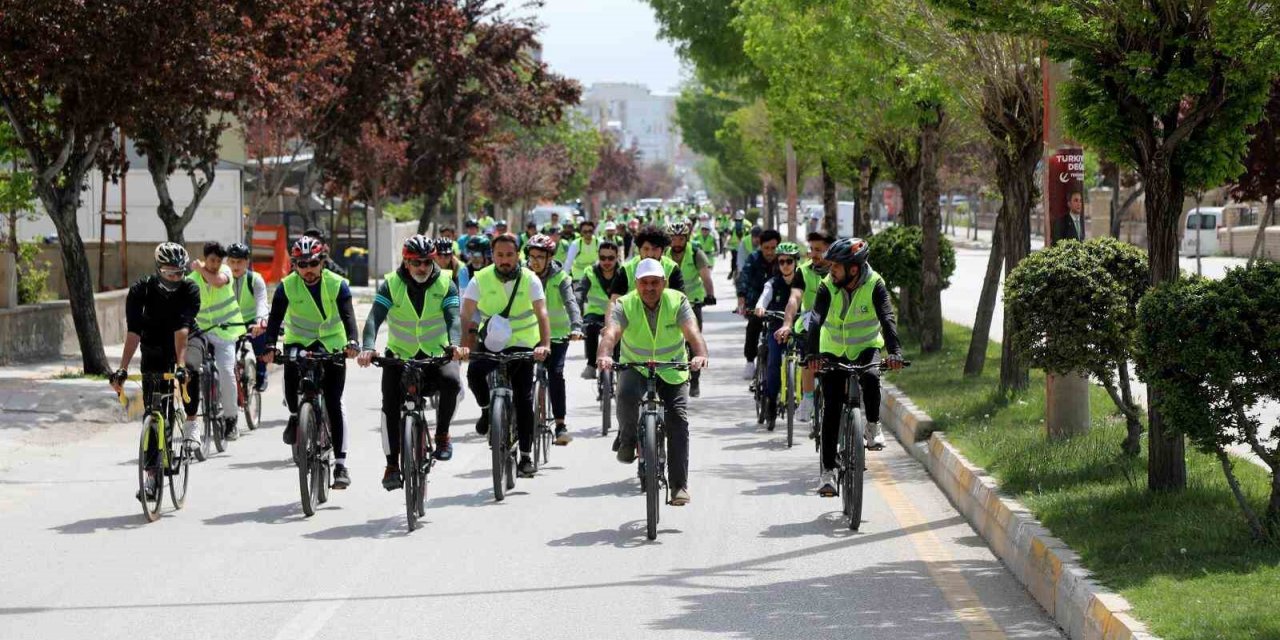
[868,458,1005,640]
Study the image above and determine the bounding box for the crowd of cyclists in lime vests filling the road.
[110,204,902,514]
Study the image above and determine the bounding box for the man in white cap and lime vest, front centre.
[596,259,707,507]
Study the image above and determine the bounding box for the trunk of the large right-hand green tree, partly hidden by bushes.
[1142,157,1187,492]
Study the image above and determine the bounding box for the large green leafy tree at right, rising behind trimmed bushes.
[966,0,1280,490]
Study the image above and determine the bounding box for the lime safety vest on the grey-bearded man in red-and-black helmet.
[383,271,453,360]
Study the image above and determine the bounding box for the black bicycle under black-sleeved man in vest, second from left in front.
[273,347,347,517]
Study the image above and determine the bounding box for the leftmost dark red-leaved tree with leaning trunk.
[0,0,168,375]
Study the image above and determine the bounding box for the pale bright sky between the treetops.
[522,0,681,93]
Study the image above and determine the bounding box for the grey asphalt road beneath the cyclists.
[0,261,1061,640]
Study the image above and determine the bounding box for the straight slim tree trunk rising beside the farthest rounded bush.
[919,106,945,353]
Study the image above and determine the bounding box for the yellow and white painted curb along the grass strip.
[882,384,1158,640]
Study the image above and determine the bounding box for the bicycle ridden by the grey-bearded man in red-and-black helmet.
[374,349,453,532]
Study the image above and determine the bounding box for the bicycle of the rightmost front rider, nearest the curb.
[817,358,911,531]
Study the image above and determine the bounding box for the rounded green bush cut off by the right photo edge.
[1135,262,1280,536]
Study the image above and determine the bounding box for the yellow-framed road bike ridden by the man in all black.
[119,366,193,522]
